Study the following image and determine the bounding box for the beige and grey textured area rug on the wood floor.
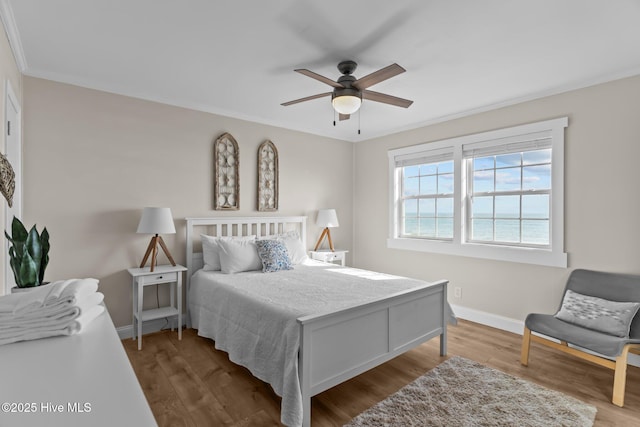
[346,356,596,427]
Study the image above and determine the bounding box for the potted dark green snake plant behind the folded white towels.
[4,216,50,288]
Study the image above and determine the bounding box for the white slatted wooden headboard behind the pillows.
[186,216,307,327]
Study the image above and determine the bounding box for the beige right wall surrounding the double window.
[354,77,640,320]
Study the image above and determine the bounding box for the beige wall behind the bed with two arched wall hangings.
[24,77,354,326]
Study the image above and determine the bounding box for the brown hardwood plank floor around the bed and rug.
[123,321,640,427]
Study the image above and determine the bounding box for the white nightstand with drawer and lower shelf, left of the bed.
[127,265,187,350]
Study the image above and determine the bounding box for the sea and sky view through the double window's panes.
[401,149,551,246]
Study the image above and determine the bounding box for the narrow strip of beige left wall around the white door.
[0,17,22,295]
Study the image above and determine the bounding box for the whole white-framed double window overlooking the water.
[388,118,568,267]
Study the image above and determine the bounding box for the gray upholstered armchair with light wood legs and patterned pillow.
[520,270,640,406]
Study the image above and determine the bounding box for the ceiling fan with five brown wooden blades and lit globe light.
[281,61,413,124]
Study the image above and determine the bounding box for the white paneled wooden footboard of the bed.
[298,280,448,427]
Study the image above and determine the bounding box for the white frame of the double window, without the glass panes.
[387,117,568,268]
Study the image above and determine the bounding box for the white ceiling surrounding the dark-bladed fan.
[0,0,640,141]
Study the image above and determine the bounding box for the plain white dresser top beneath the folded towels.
[0,310,157,427]
